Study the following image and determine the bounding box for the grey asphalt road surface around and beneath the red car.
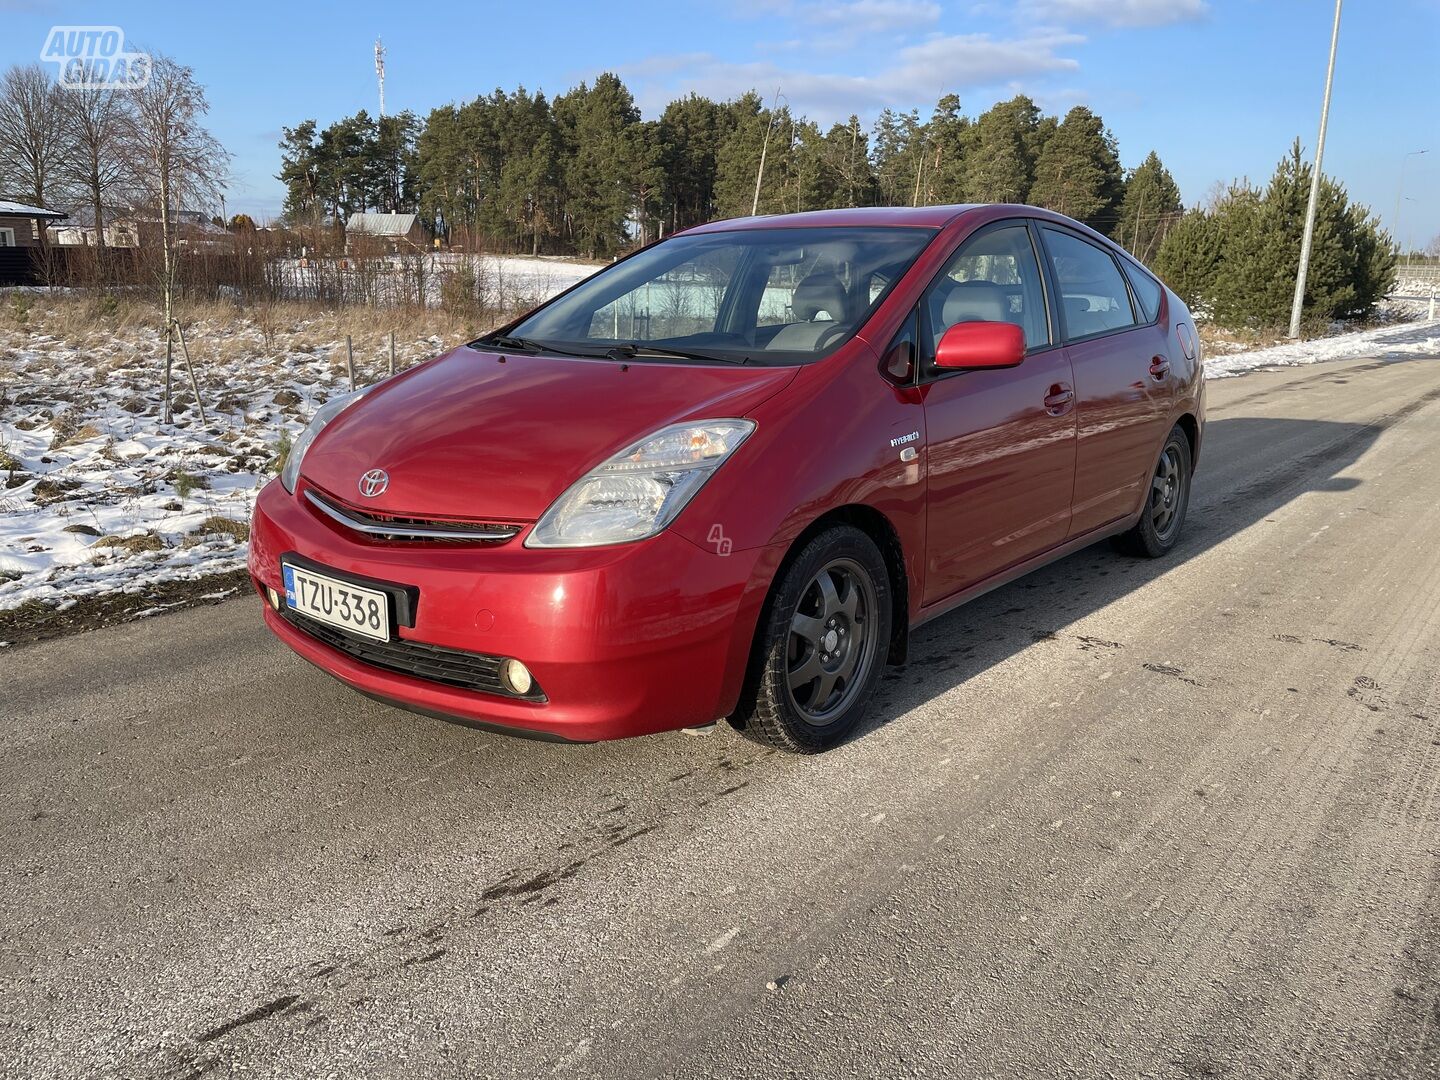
[0,348,1440,1077]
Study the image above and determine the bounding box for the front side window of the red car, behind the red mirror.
[920,225,1050,368]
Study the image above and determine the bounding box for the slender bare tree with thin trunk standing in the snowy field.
[134,53,230,423]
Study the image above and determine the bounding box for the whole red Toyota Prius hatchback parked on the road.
[249,206,1204,753]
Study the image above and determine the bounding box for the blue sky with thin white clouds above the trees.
[0,0,1440,245]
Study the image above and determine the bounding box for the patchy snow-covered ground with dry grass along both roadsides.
[0,259,1440,638]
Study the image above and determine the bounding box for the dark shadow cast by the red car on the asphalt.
[855,408,1405,739]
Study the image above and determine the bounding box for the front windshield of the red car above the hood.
[505,228,935,364]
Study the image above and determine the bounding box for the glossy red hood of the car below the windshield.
[301,346,799,521]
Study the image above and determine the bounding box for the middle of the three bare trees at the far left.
[60,89,135,266]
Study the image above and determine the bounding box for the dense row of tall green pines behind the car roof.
[279,73,1182,258]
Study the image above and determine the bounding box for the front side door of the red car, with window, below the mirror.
[920,220,1076,603]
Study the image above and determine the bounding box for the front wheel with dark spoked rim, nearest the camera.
[732,526,893,753]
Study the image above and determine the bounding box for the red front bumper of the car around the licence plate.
[249,482,782,742]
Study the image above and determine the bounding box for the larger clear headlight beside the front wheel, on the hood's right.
[526,420,755,547]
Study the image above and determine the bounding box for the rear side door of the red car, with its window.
[1040,223,1175,536]
